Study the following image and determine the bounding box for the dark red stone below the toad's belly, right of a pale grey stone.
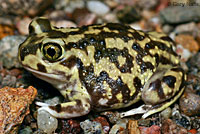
[93,116,110,134]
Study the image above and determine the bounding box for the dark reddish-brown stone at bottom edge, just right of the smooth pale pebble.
[61,119,81,134]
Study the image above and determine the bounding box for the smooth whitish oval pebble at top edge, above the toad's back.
[87,0,110,16]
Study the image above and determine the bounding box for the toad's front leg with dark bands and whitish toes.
[36,96,91,119]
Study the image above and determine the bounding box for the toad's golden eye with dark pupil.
[42,43,62,61]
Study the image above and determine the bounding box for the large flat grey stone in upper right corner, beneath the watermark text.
[160,6,200,24]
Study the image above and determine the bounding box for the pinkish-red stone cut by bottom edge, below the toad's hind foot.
[139,125,161,134]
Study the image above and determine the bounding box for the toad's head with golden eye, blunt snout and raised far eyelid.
[18,17,75,83]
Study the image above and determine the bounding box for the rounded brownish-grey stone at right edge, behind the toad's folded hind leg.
[179,91,200,116]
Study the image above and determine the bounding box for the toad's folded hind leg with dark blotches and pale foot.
[120,67,186,118]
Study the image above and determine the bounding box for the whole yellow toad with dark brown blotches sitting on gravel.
[18,18,186,118]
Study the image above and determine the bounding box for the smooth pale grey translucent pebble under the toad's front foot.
[37,109,58,134]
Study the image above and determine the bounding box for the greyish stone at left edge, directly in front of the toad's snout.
[0,36,26,69]
